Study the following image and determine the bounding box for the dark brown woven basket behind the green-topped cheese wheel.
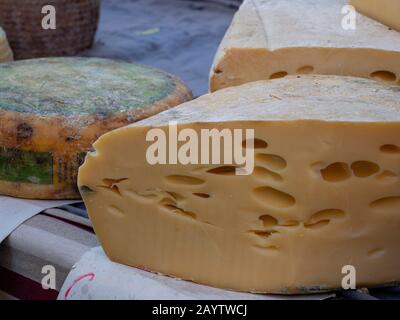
[0,0,100,59]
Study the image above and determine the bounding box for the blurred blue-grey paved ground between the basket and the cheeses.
[85,0,237,96]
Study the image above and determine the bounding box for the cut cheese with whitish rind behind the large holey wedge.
[210,0,400,91]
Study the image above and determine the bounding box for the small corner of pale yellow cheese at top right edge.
[349,0,400,31]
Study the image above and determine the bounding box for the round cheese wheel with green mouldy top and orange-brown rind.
[0,58,191,199]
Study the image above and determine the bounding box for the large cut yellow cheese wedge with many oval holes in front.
[78,75,400,293]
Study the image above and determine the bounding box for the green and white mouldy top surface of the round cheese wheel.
[0,58,176,116]
